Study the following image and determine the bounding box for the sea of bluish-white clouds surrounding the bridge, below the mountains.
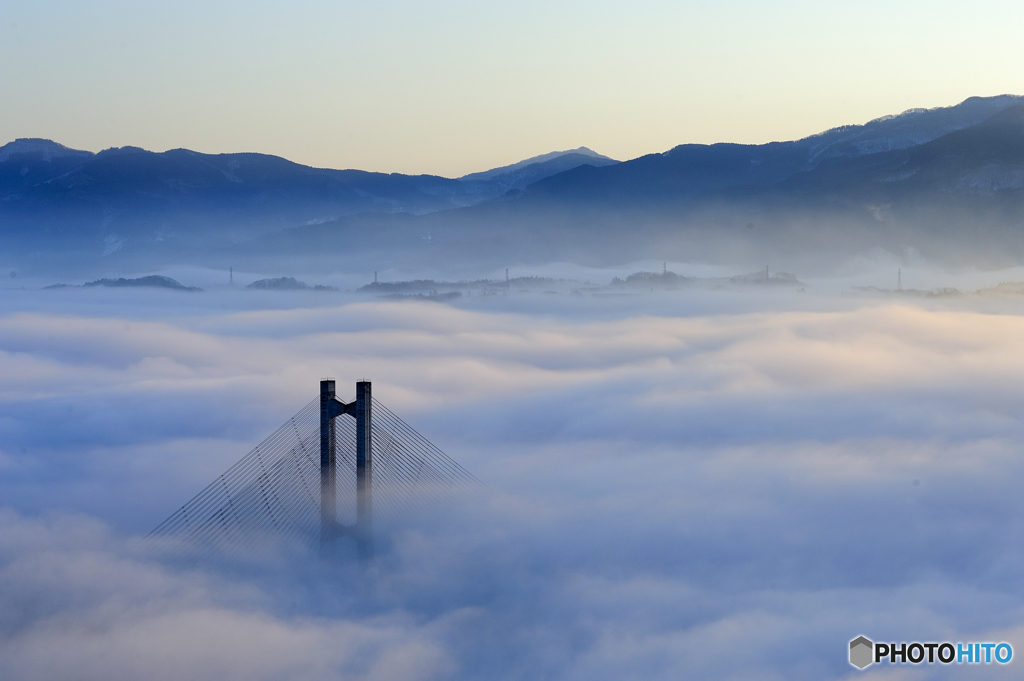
[0,274,1024,681]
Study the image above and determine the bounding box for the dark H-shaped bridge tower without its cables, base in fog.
[321,379,374,557]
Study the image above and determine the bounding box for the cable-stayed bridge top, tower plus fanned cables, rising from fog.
[150,380,480,556]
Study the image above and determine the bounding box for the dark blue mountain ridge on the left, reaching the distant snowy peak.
[0,139,608,261]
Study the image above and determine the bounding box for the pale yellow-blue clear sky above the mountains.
[0,0,1024,175]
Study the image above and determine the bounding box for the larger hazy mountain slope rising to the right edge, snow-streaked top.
[272,97,1024,273]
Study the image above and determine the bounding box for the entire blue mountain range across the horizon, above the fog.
[6,95,1024,276]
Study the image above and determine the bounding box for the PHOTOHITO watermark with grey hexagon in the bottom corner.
[850,636,1014,669]
